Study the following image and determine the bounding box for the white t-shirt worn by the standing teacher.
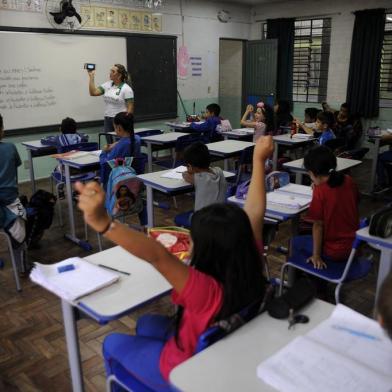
[99,81,134,117]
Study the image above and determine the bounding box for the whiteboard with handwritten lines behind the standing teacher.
[0,32,127,130]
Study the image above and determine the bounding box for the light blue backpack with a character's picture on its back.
[105,158,143,216]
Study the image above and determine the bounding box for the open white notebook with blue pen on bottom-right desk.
[257,304,392,392]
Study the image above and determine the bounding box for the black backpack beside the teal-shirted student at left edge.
[21,189,56,248]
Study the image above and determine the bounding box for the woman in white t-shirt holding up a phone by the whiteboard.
[88,64,134,132]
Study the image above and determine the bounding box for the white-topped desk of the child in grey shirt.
[138,169,235,227]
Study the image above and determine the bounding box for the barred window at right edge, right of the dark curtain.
[380,14,392,107]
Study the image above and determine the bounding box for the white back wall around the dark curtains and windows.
[251,0,392,128]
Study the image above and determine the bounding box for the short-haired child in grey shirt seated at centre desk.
[175,142,227,227]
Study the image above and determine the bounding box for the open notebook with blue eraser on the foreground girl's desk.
[30,257,120,302]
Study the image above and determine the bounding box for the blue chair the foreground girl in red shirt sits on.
[106,300,264,392]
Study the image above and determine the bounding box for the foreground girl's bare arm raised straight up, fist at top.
[244,136,274,242]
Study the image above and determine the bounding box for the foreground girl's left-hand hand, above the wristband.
[75,181,110,232]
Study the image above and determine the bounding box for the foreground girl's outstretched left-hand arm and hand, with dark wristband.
[75,182,189,292]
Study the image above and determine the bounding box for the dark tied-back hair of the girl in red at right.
[304,146,344,188]
